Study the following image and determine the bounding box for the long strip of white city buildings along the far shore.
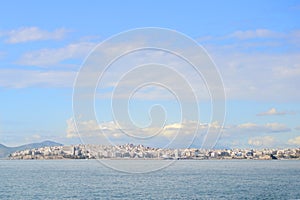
[8,144,300,160]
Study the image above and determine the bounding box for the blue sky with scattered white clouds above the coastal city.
[0,0,300,148]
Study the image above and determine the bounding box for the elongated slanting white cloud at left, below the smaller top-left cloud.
[17,42,95,67]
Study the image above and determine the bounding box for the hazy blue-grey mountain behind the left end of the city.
[0,141,63,158]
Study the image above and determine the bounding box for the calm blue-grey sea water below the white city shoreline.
[0,160,300,199]
